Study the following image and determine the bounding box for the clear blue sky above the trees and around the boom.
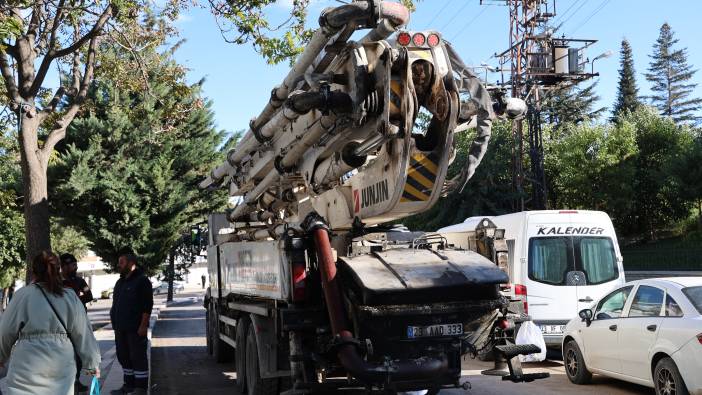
[170,0,702,132]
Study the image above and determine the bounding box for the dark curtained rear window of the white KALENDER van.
[529,236,619,285]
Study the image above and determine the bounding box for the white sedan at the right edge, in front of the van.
[563,277,702,395]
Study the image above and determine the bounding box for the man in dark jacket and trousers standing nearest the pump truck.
[110,252,154,395]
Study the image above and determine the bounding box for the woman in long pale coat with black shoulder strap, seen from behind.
[0,251,100,395]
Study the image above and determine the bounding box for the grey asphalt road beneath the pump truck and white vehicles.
[151,294,653,395]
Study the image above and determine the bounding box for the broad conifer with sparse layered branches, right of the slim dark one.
[646,23,702,123]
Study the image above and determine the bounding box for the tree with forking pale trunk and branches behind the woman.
[0,0,115,272]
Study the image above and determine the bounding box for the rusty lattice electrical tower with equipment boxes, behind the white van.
[480,0,599,211]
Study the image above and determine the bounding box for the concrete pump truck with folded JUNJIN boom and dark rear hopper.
[200,0,547,395]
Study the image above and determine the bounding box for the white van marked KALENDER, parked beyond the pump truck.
[437,210,625,348]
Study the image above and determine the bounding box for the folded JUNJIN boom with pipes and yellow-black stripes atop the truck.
[200,0,526,240]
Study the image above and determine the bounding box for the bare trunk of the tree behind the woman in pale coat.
[18,113,51,282]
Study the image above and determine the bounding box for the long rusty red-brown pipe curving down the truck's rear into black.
[304,214,448,384]
